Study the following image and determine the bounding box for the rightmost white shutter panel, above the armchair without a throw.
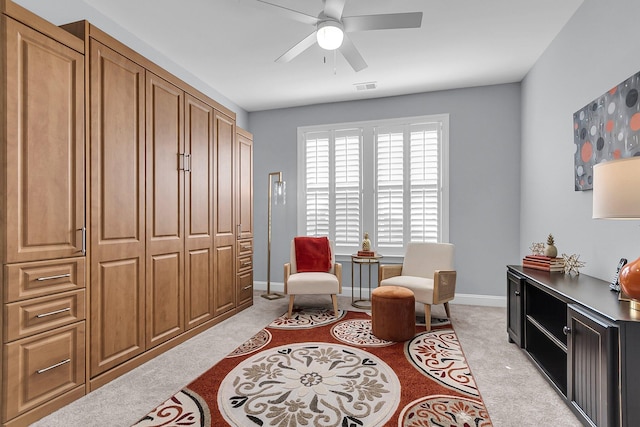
[409,123,439,242]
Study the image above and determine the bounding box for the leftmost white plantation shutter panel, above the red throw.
[305,132,330,236]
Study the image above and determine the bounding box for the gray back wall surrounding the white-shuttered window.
[249,84,521,296]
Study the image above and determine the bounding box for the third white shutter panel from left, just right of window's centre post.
[375,128,404,248]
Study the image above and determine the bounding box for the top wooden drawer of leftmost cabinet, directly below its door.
[5,258,85,302]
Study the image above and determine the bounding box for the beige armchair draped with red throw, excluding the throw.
[284,240,342,317]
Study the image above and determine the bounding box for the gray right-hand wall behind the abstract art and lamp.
[520,0,640,280]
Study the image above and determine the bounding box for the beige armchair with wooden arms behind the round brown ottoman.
[378,242,456,331]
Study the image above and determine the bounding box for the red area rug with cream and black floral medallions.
[135,308,492,427]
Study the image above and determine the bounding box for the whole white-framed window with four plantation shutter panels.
[298,115,449,255]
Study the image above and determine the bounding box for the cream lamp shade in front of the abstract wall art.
[593,157,640,219]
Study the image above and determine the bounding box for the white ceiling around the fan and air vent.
[17,0,583,111]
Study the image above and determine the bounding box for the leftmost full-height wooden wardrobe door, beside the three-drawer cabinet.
[90,40,145,377]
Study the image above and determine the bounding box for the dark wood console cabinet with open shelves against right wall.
[507,265,640,427]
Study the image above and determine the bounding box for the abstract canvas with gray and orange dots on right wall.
[573,72,640,191]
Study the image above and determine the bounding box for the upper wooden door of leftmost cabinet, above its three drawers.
[2,17,84,262]
